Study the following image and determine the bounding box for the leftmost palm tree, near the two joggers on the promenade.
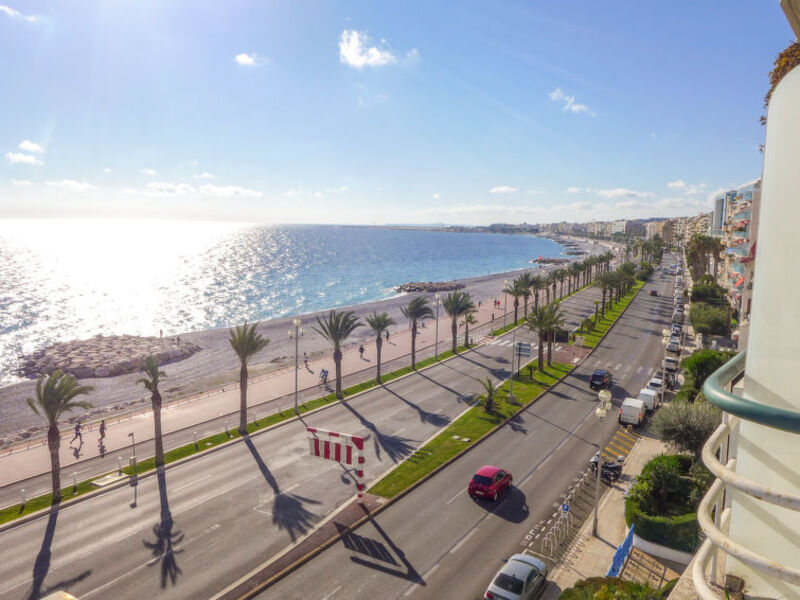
[28,371,94,504]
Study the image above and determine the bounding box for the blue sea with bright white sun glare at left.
[0,219,562,385]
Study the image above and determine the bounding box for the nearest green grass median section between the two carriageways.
[368,363,572,498]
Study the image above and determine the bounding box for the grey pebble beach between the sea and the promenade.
[0,236,608,438]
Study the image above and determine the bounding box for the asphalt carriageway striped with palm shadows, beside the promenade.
[0,278,612,600]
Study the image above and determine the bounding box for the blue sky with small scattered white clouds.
[0,0,794,225]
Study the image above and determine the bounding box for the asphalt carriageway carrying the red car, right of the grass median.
[266,257,672,600]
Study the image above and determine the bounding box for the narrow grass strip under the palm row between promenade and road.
[0,346,468,525]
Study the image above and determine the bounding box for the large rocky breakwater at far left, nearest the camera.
[19,335,201,379]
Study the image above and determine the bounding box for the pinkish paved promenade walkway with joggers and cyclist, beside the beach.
[0,290,596,496]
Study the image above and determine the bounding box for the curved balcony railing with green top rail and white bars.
[692,352,800,600]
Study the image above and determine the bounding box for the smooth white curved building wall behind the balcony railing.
[726,67,800,598]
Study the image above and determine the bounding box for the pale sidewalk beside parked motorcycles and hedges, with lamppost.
[542,434,683,600]
